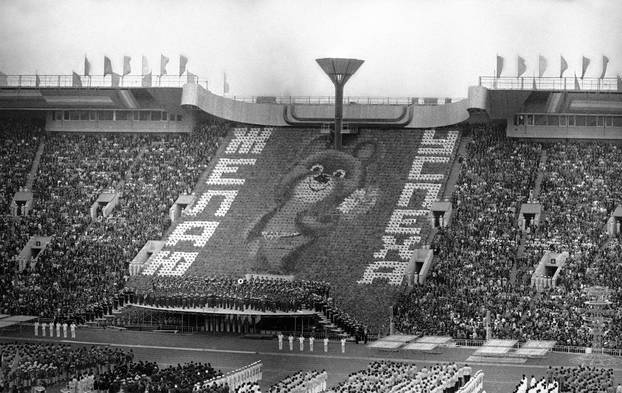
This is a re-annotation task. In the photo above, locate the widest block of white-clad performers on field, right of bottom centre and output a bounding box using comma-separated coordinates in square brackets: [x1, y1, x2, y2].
[327, 361, 471, 393]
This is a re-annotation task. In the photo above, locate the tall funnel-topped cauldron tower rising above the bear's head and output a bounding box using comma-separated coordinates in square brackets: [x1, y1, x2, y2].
[315, 58, 364, 150]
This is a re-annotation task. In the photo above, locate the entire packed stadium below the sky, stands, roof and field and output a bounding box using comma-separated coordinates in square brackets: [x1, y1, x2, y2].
[0, 2, 622, 393]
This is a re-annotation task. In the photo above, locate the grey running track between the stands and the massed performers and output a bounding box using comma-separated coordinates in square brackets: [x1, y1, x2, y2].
[0, 329, 622, 393]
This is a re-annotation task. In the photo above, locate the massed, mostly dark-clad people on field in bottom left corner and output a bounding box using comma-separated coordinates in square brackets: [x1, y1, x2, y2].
[0, 343, 259, 393]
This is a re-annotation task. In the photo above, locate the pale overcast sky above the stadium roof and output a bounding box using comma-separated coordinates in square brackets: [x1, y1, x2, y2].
[0, 0, 622, 97]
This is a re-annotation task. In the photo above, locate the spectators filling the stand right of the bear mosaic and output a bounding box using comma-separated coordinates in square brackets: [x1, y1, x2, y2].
[394, 125, 622, 348]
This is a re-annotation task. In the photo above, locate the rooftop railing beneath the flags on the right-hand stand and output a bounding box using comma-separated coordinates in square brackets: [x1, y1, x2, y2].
[479, 76, 622, 91]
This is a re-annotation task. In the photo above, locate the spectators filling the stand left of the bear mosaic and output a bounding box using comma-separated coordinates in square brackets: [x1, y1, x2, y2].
[0, 118, 227, 322]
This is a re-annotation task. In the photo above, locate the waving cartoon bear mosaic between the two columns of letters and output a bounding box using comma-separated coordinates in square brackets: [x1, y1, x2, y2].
[247, 139, 377, 274]
